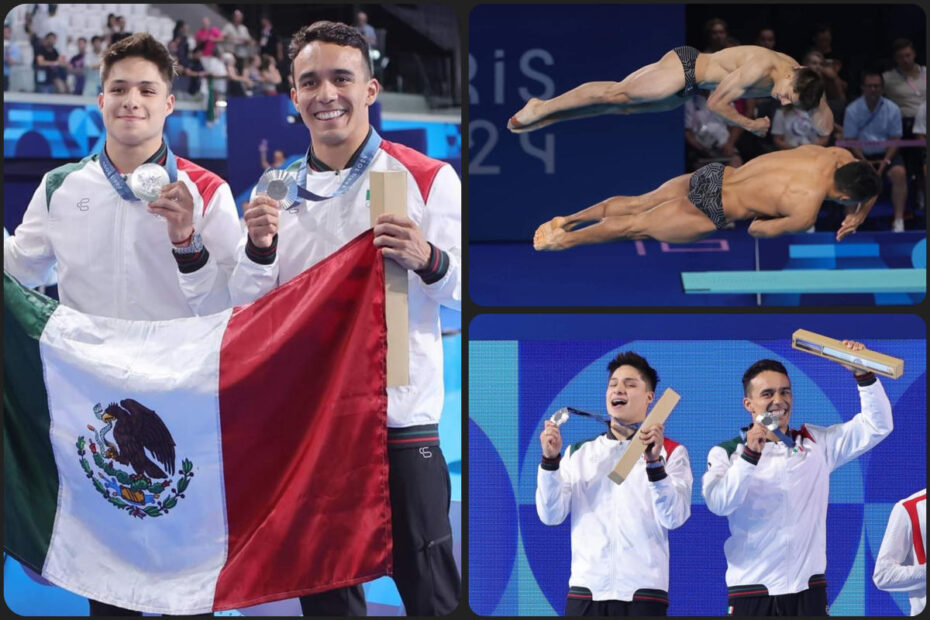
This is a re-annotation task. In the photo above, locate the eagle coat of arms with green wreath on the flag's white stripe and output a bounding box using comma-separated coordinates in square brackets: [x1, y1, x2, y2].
[75, 398, 194, 519]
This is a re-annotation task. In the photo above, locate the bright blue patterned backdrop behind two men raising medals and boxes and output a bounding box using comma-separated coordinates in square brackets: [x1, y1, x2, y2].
[468, 314, 927, 616]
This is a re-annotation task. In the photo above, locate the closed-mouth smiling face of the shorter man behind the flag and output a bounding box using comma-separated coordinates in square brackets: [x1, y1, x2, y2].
[97, 56, 174, 151]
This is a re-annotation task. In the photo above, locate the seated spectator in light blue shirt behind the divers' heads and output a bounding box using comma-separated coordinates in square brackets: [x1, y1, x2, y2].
[843, 69, 907, 232]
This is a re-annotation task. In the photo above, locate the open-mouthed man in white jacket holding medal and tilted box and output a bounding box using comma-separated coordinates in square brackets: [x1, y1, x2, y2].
[536, 352, 692, 616]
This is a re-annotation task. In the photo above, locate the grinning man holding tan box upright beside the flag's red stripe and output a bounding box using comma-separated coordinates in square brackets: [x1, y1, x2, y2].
[230, 22, 462, 616]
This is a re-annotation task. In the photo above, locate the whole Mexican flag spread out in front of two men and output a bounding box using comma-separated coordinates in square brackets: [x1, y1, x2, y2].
[3, 231, 391, 614]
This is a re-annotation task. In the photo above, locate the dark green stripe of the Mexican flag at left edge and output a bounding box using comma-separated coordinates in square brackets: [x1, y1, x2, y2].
[3, 273, 58, 572]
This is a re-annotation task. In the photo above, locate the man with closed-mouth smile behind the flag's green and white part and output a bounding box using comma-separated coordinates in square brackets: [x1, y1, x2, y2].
[3, 33, 241, 616]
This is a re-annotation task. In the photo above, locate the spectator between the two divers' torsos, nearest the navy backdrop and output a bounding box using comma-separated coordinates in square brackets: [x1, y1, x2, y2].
[685, 90, 743, 172]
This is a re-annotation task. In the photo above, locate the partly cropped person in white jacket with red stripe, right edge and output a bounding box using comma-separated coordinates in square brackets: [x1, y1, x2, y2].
[872, 489, 927, 616]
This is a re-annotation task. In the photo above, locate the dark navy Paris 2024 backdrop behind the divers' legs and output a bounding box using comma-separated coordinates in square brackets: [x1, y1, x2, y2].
[468, 5, 685, 242]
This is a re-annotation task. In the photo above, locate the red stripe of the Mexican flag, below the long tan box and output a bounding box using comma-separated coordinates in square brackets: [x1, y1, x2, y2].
[214, 231, 392, 610]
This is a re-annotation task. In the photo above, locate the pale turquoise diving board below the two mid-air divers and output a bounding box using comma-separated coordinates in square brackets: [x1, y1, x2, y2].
[681, 269, 927, 294]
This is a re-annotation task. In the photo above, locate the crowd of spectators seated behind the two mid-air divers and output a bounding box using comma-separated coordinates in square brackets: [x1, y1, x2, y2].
[685, 18, 927, 231]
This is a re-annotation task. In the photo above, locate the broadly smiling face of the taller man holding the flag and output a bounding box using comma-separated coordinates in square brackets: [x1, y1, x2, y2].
[291, 41, 380, 153]
